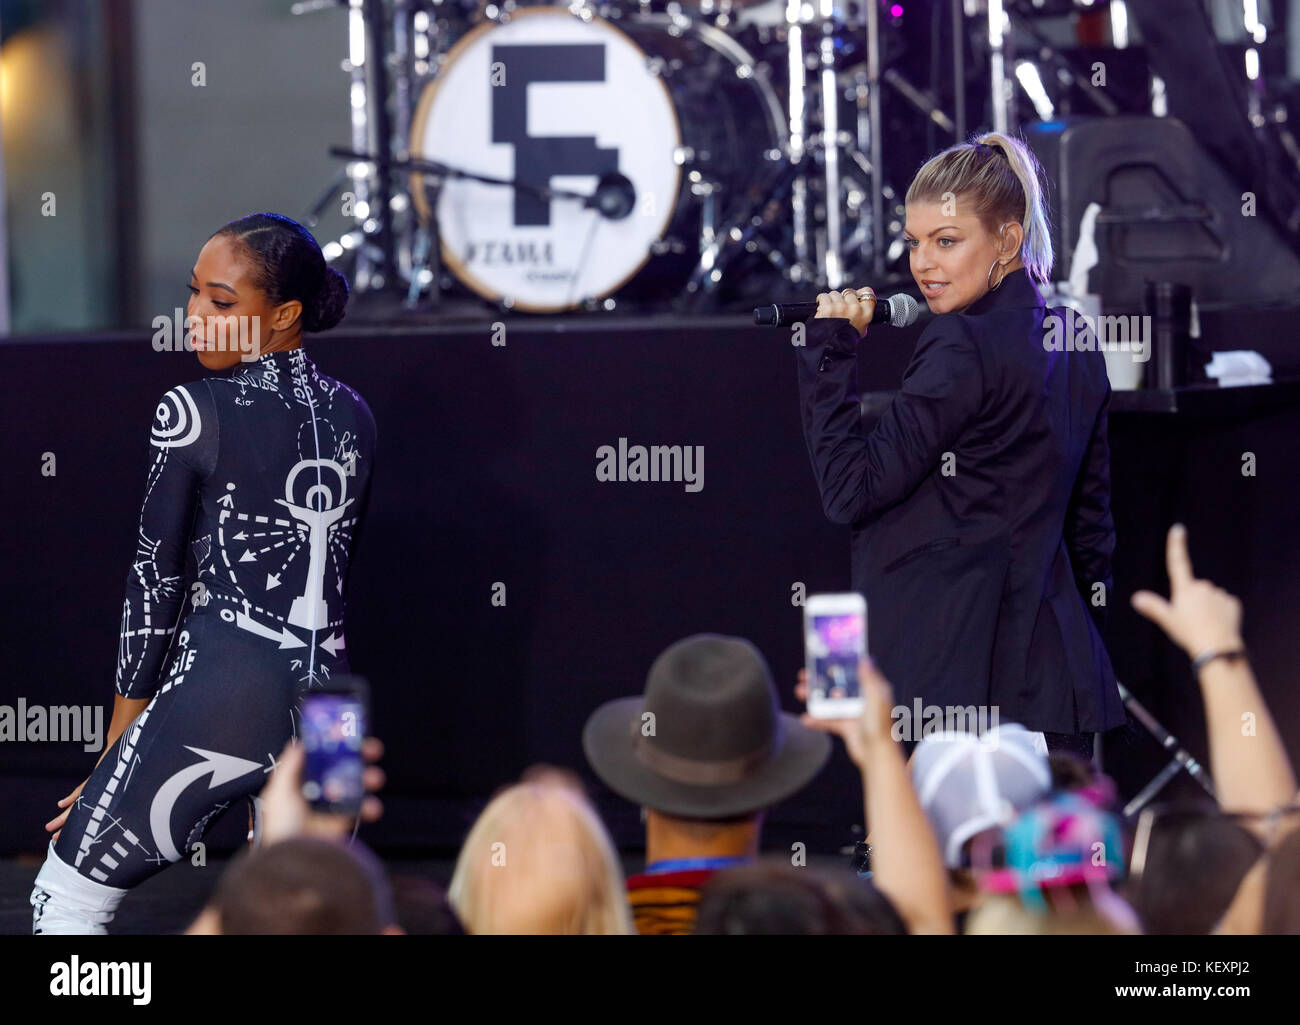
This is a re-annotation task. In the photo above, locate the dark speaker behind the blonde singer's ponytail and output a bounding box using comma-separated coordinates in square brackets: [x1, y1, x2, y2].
[1023, 117, 1300, 313]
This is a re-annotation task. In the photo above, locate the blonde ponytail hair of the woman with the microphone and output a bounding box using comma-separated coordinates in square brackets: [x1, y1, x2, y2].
[905, 131, 1052, 284]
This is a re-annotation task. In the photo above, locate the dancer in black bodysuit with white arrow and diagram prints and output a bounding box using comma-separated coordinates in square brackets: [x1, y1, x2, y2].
[31, 213, 374, 933]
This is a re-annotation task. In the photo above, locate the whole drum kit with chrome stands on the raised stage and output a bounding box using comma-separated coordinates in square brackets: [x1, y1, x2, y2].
[295, 0, 959, 313]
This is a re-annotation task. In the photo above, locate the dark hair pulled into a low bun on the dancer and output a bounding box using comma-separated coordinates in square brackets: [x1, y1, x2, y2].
[212, 213, 347, 332]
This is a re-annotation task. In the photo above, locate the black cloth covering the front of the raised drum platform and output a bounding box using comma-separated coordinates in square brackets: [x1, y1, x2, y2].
[0, 319, 1300, 853]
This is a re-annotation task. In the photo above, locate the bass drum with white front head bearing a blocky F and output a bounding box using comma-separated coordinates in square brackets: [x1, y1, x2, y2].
[411, 8, 787, 312]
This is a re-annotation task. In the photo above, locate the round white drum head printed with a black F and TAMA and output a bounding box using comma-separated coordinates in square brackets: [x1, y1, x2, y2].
[411, 8, 681, 312]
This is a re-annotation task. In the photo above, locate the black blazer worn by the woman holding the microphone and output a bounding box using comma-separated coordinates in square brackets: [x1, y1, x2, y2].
[796, 269, 1125, 734]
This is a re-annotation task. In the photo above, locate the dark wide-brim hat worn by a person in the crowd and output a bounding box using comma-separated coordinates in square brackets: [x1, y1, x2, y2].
[582, 633, 831, 819]
